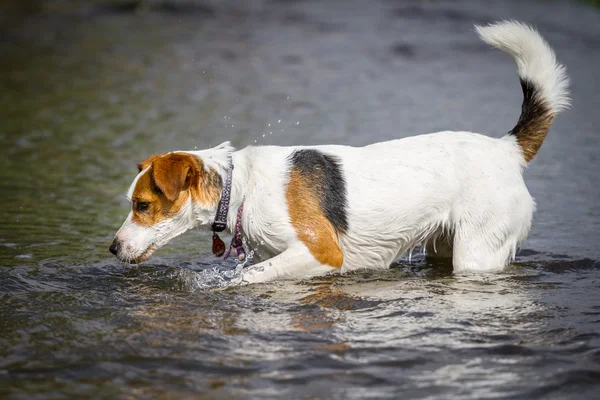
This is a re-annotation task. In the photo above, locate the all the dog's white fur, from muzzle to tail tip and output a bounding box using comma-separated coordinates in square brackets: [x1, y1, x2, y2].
[111, 22, 568, 283]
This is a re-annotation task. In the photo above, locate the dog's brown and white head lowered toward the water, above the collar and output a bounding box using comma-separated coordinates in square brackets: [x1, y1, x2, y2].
[110, 142, 233, 263]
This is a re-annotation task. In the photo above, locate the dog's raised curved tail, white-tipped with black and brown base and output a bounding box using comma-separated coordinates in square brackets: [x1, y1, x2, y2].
[475, 21, 570, 162]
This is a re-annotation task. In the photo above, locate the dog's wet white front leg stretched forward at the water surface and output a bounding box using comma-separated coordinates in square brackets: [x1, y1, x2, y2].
[240, 244, 340, 284]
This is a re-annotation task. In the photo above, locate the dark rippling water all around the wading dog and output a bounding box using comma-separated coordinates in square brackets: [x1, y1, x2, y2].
[0, 0, 600, 399]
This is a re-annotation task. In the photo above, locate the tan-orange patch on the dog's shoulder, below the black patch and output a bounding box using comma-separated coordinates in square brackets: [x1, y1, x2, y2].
[286, 167, 344, 268]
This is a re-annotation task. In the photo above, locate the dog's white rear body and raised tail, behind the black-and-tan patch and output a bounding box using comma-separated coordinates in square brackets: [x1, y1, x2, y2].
[288, 21, 569, 271]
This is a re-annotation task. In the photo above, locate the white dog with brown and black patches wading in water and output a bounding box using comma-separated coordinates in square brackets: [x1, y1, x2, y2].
[110, 21, 570, 283]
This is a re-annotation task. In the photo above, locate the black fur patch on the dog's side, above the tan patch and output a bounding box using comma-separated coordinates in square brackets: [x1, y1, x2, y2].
[290, 149, 348, 233]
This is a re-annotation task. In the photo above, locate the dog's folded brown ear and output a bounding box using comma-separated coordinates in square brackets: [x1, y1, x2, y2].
[152, 153, 200, 201]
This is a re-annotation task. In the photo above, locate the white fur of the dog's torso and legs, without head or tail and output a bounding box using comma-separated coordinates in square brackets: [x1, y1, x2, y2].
[229, 132, 535, 281]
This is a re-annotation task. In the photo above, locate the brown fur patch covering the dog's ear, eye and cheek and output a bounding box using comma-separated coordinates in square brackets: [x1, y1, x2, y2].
[131, 153, 222, 226]
